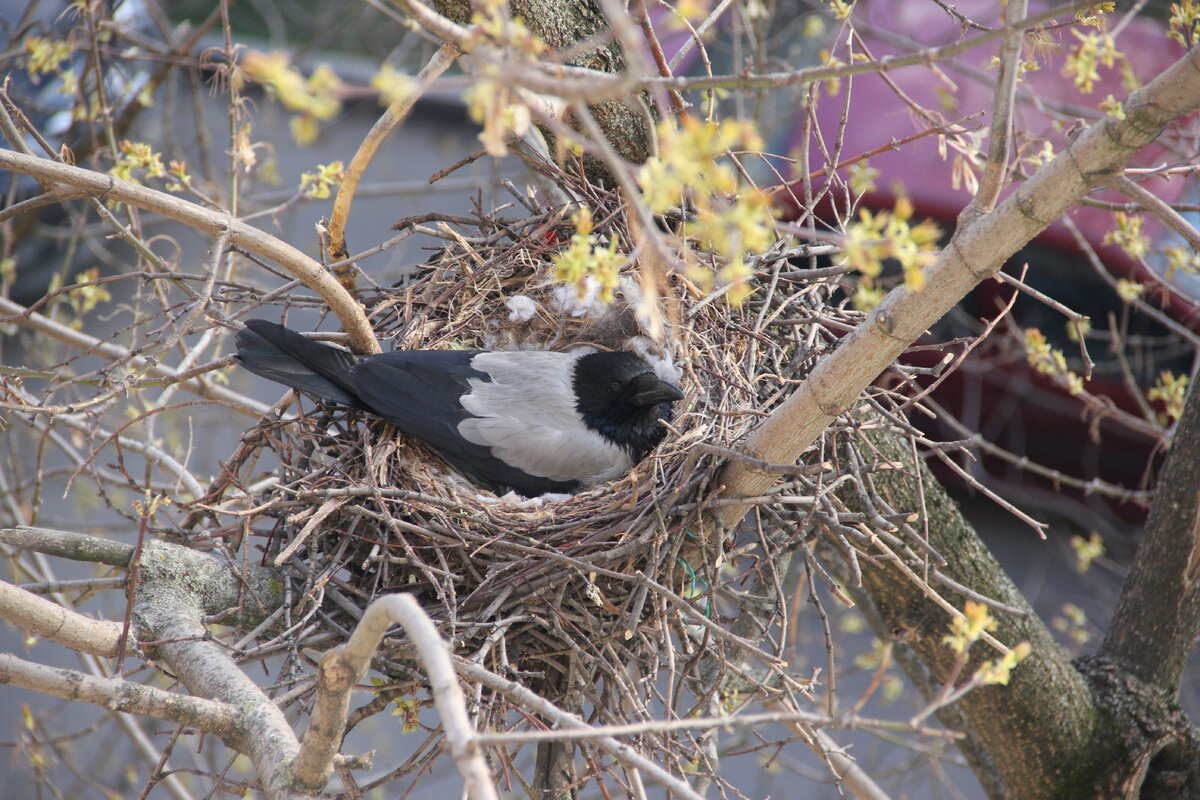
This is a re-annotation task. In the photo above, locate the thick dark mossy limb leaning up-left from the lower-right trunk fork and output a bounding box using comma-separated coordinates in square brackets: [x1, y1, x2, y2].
[863, 432, 1111, 800]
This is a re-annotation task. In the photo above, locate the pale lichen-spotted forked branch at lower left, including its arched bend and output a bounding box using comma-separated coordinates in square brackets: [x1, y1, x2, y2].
[0, 528, 498, 800]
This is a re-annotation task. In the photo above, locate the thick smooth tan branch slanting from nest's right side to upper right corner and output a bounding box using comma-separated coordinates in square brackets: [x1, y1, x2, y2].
[719, 42, 1200, 529]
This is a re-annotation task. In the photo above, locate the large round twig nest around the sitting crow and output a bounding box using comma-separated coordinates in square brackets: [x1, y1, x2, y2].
[196, 181, 848, 700]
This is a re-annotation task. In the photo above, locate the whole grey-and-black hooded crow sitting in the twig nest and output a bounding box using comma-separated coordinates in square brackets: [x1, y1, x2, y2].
[236, 319, 683, 497]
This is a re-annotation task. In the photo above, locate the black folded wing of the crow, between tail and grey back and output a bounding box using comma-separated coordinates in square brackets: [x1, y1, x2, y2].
[350, 350, 580, 495]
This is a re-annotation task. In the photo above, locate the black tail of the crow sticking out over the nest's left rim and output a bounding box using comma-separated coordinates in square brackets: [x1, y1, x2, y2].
[235, 319, 362, 408]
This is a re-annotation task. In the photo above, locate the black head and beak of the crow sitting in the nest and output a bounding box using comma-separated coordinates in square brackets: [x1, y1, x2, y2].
[574, 353, 683, 461]
